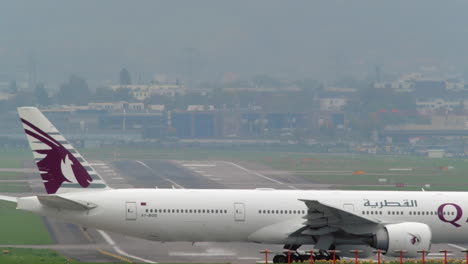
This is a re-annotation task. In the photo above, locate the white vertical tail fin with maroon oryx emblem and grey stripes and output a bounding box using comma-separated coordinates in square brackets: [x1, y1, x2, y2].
[18, 107, 108, 194]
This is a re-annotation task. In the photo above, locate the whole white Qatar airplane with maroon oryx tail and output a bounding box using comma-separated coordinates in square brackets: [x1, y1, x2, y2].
[0, 107, 468, 263]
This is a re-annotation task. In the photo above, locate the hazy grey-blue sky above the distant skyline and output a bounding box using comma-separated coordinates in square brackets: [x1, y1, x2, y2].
[0, 0, 468, 86]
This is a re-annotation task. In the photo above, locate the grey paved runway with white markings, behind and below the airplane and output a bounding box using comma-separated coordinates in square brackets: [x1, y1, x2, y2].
[5, 160, 468, 263]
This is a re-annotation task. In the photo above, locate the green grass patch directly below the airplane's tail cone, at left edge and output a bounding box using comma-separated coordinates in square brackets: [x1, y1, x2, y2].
[0, 202, 52, 244]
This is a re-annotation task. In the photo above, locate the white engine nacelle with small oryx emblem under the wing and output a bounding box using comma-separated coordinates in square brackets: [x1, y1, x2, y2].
[371, 222, 432, 258]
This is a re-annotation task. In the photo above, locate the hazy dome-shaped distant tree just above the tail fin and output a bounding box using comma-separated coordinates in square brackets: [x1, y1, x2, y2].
[57, 75, 91, 105]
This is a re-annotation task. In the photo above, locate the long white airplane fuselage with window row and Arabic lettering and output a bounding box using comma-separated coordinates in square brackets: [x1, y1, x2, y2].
[18, 189, 468, 244]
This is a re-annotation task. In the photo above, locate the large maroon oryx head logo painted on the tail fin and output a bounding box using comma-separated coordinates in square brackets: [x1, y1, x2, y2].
[21, 118, 93, 194]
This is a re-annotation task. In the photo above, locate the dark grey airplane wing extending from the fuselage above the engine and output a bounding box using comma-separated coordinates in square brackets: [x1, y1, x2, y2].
[298, 199, 380, 236]
